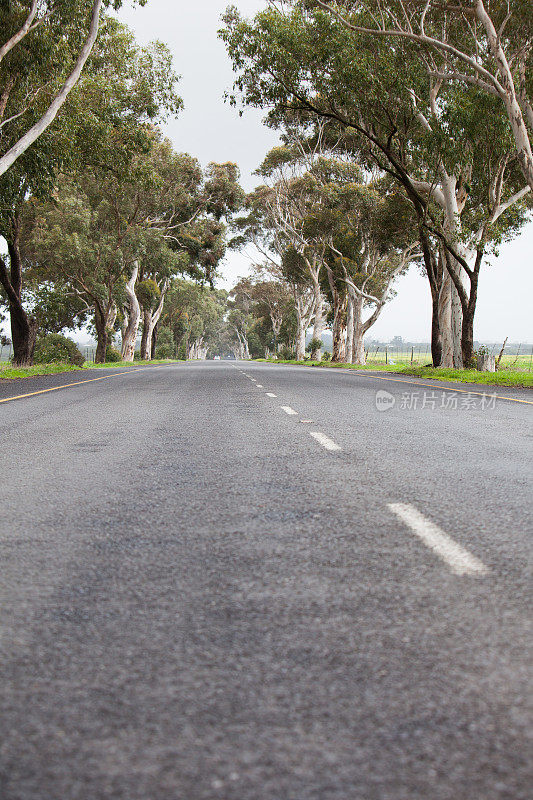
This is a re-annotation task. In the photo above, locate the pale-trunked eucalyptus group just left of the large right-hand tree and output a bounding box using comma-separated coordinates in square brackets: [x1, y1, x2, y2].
[249, 131, 416, 362]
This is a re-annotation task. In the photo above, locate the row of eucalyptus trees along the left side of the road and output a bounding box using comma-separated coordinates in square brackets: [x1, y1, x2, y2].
[0, 0, 243, 365]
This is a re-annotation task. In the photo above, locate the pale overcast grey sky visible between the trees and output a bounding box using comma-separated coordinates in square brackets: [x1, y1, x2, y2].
[120, 0, 533, 342]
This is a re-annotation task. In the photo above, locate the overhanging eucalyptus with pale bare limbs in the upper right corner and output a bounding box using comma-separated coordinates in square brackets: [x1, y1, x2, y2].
[316, 0, 533, 191]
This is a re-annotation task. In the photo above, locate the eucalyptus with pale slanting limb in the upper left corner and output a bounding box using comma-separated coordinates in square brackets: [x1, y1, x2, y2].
[0, 0, 146, 176]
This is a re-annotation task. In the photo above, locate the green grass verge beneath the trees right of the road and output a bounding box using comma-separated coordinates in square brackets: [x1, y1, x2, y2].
[256, 358, 533, 388]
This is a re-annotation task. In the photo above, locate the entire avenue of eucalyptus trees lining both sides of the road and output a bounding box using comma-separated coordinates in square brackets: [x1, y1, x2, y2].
[0, 0, 533, 368]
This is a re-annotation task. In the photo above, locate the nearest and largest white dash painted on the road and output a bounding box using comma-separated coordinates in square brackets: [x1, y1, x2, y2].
[387, 503, 490, 575]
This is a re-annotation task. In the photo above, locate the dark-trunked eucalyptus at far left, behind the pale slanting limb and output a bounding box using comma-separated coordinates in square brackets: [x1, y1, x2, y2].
[0, 18, 181, 363]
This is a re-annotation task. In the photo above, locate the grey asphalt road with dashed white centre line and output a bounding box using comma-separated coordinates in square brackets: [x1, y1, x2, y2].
[0, 362, 533, 800]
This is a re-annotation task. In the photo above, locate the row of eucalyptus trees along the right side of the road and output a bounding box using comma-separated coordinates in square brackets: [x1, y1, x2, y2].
[220, 0, 533, 368]
